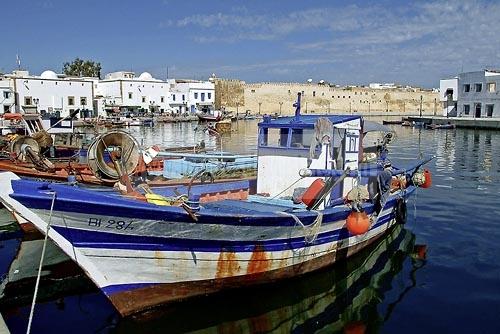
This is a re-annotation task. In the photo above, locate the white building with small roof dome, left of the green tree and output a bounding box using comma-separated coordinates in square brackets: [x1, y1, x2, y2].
[5, 71, 94, 117]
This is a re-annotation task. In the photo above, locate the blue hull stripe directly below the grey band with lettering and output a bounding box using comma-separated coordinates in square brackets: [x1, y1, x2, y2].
[52, 213, 394, 253]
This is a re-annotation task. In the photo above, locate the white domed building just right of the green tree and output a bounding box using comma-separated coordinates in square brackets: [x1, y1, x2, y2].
[94, 71, 169, 116]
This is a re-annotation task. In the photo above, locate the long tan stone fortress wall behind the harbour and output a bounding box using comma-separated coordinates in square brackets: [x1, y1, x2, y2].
[215, 79, 440, 115]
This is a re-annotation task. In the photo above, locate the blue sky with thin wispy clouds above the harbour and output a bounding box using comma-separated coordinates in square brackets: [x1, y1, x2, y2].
[0, 0, 500, 87]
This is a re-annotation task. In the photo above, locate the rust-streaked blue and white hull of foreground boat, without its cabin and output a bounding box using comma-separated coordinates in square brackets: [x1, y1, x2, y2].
[0, 173, 411, 316]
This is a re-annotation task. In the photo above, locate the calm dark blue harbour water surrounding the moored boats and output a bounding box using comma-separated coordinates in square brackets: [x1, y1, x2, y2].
[0, 121, 500, 333]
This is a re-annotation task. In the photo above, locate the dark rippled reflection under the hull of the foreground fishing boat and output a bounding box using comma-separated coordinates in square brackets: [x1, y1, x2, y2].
[115, 225, 425, 333]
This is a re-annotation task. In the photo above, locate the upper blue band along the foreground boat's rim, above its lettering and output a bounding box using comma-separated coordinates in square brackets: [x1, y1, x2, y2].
[11, 177, 414, 226]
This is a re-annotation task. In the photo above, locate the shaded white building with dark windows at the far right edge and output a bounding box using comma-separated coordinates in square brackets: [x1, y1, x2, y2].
[457, 70, 500, 118]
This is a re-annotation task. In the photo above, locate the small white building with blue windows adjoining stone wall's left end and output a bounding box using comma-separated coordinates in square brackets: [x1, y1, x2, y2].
[168, 79, 215, 114]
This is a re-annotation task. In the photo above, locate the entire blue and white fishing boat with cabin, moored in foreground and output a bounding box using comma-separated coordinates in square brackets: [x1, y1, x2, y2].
[0, 94, 430, 316]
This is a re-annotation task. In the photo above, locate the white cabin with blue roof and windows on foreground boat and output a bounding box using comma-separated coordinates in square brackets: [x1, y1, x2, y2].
[257, 112, 362, 198]
